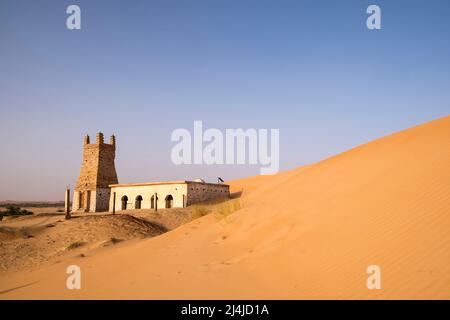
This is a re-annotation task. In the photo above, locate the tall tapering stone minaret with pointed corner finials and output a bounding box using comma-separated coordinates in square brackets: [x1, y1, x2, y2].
[72, 132, 118, 212]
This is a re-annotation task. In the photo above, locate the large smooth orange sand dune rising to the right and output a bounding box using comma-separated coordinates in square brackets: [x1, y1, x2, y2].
[0, 117, 450, 299]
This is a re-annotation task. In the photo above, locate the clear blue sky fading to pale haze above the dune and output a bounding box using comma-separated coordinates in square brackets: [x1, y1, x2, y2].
[0, 0, 450, 200]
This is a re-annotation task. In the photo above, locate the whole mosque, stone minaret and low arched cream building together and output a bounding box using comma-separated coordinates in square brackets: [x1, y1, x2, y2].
[72, 132, 230, 212]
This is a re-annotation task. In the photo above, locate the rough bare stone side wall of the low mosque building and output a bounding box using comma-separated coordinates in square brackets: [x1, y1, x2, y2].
[187, 182, 230, 206]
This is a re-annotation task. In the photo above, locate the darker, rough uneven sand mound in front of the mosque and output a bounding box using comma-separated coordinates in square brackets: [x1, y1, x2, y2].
[0, 209, 197, 274]
